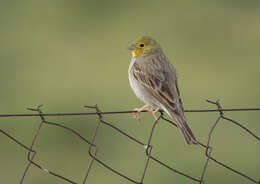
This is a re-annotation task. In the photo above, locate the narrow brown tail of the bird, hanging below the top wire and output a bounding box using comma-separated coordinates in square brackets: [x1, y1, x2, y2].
[169, 111, 198, 144]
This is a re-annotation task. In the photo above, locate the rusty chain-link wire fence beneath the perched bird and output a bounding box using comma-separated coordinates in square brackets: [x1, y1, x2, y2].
[0, 100, 260, 184]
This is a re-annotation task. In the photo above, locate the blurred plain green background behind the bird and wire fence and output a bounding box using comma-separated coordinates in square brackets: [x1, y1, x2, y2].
[0, 0, 260, 184]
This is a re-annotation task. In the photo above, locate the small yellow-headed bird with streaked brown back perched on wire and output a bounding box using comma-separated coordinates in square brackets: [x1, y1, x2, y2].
[128, 36, 198, 144]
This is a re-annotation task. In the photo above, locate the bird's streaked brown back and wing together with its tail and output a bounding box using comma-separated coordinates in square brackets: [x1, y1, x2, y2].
[132, 55, 198, 144]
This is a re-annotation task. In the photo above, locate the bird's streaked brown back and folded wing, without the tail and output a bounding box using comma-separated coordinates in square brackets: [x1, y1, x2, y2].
[133, 54, 183, 110]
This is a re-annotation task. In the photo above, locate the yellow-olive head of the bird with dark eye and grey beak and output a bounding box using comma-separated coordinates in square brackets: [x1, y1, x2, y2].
[128, 36, 161, 57]
